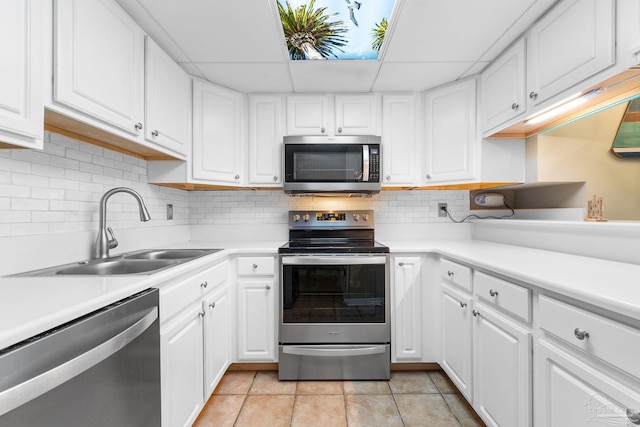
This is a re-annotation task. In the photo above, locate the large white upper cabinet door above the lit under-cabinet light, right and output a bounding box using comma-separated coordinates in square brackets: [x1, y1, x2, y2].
[527, 0, 615, 106]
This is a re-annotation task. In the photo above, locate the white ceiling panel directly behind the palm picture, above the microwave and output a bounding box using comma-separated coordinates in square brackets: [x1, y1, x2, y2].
[289, 61, 380, 92]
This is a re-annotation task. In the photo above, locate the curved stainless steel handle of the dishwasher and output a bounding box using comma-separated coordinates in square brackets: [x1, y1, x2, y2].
[0, 307, 158, 415]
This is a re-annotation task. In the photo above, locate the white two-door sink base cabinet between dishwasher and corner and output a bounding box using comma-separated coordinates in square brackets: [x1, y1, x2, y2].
[160, 260, 231, 427]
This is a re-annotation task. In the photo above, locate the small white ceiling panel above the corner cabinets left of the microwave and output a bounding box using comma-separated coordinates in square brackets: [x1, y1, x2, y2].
[194, 62, 293, 93]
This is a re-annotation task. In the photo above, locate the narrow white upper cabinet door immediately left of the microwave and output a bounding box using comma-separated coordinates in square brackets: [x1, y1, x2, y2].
[249, 95, 283, 185]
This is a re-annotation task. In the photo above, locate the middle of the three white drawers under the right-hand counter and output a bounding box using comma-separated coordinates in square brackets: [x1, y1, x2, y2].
[473, 272, 531, 323]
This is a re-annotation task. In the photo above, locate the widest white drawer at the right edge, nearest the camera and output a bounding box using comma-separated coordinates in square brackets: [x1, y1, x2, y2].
[539, 295, 640, 378]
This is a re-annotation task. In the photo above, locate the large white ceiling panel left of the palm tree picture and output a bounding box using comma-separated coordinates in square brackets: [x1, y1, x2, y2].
[138, 0, 285, 62]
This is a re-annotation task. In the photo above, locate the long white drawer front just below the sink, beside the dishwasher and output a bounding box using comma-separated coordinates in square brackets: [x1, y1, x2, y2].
[160, 261, 229, 323]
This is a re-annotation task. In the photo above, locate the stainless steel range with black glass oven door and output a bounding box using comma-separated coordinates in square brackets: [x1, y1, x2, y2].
[279, 210, 391, 380]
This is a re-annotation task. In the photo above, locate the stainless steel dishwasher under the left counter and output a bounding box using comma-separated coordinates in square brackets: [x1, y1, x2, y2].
[0, 289, 160, 427]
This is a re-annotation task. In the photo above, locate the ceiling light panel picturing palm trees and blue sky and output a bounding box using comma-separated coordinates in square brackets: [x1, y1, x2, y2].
[278, 0, 395, 60]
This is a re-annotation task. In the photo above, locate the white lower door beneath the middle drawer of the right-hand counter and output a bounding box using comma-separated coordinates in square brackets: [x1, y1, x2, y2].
[473, 303, 532, 427]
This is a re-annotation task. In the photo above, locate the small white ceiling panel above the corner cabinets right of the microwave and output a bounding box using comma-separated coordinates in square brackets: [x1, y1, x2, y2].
[373, 62, 473, 92]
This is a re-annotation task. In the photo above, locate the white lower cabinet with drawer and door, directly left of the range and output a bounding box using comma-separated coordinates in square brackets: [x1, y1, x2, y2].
[236, 256, 277, 362]
